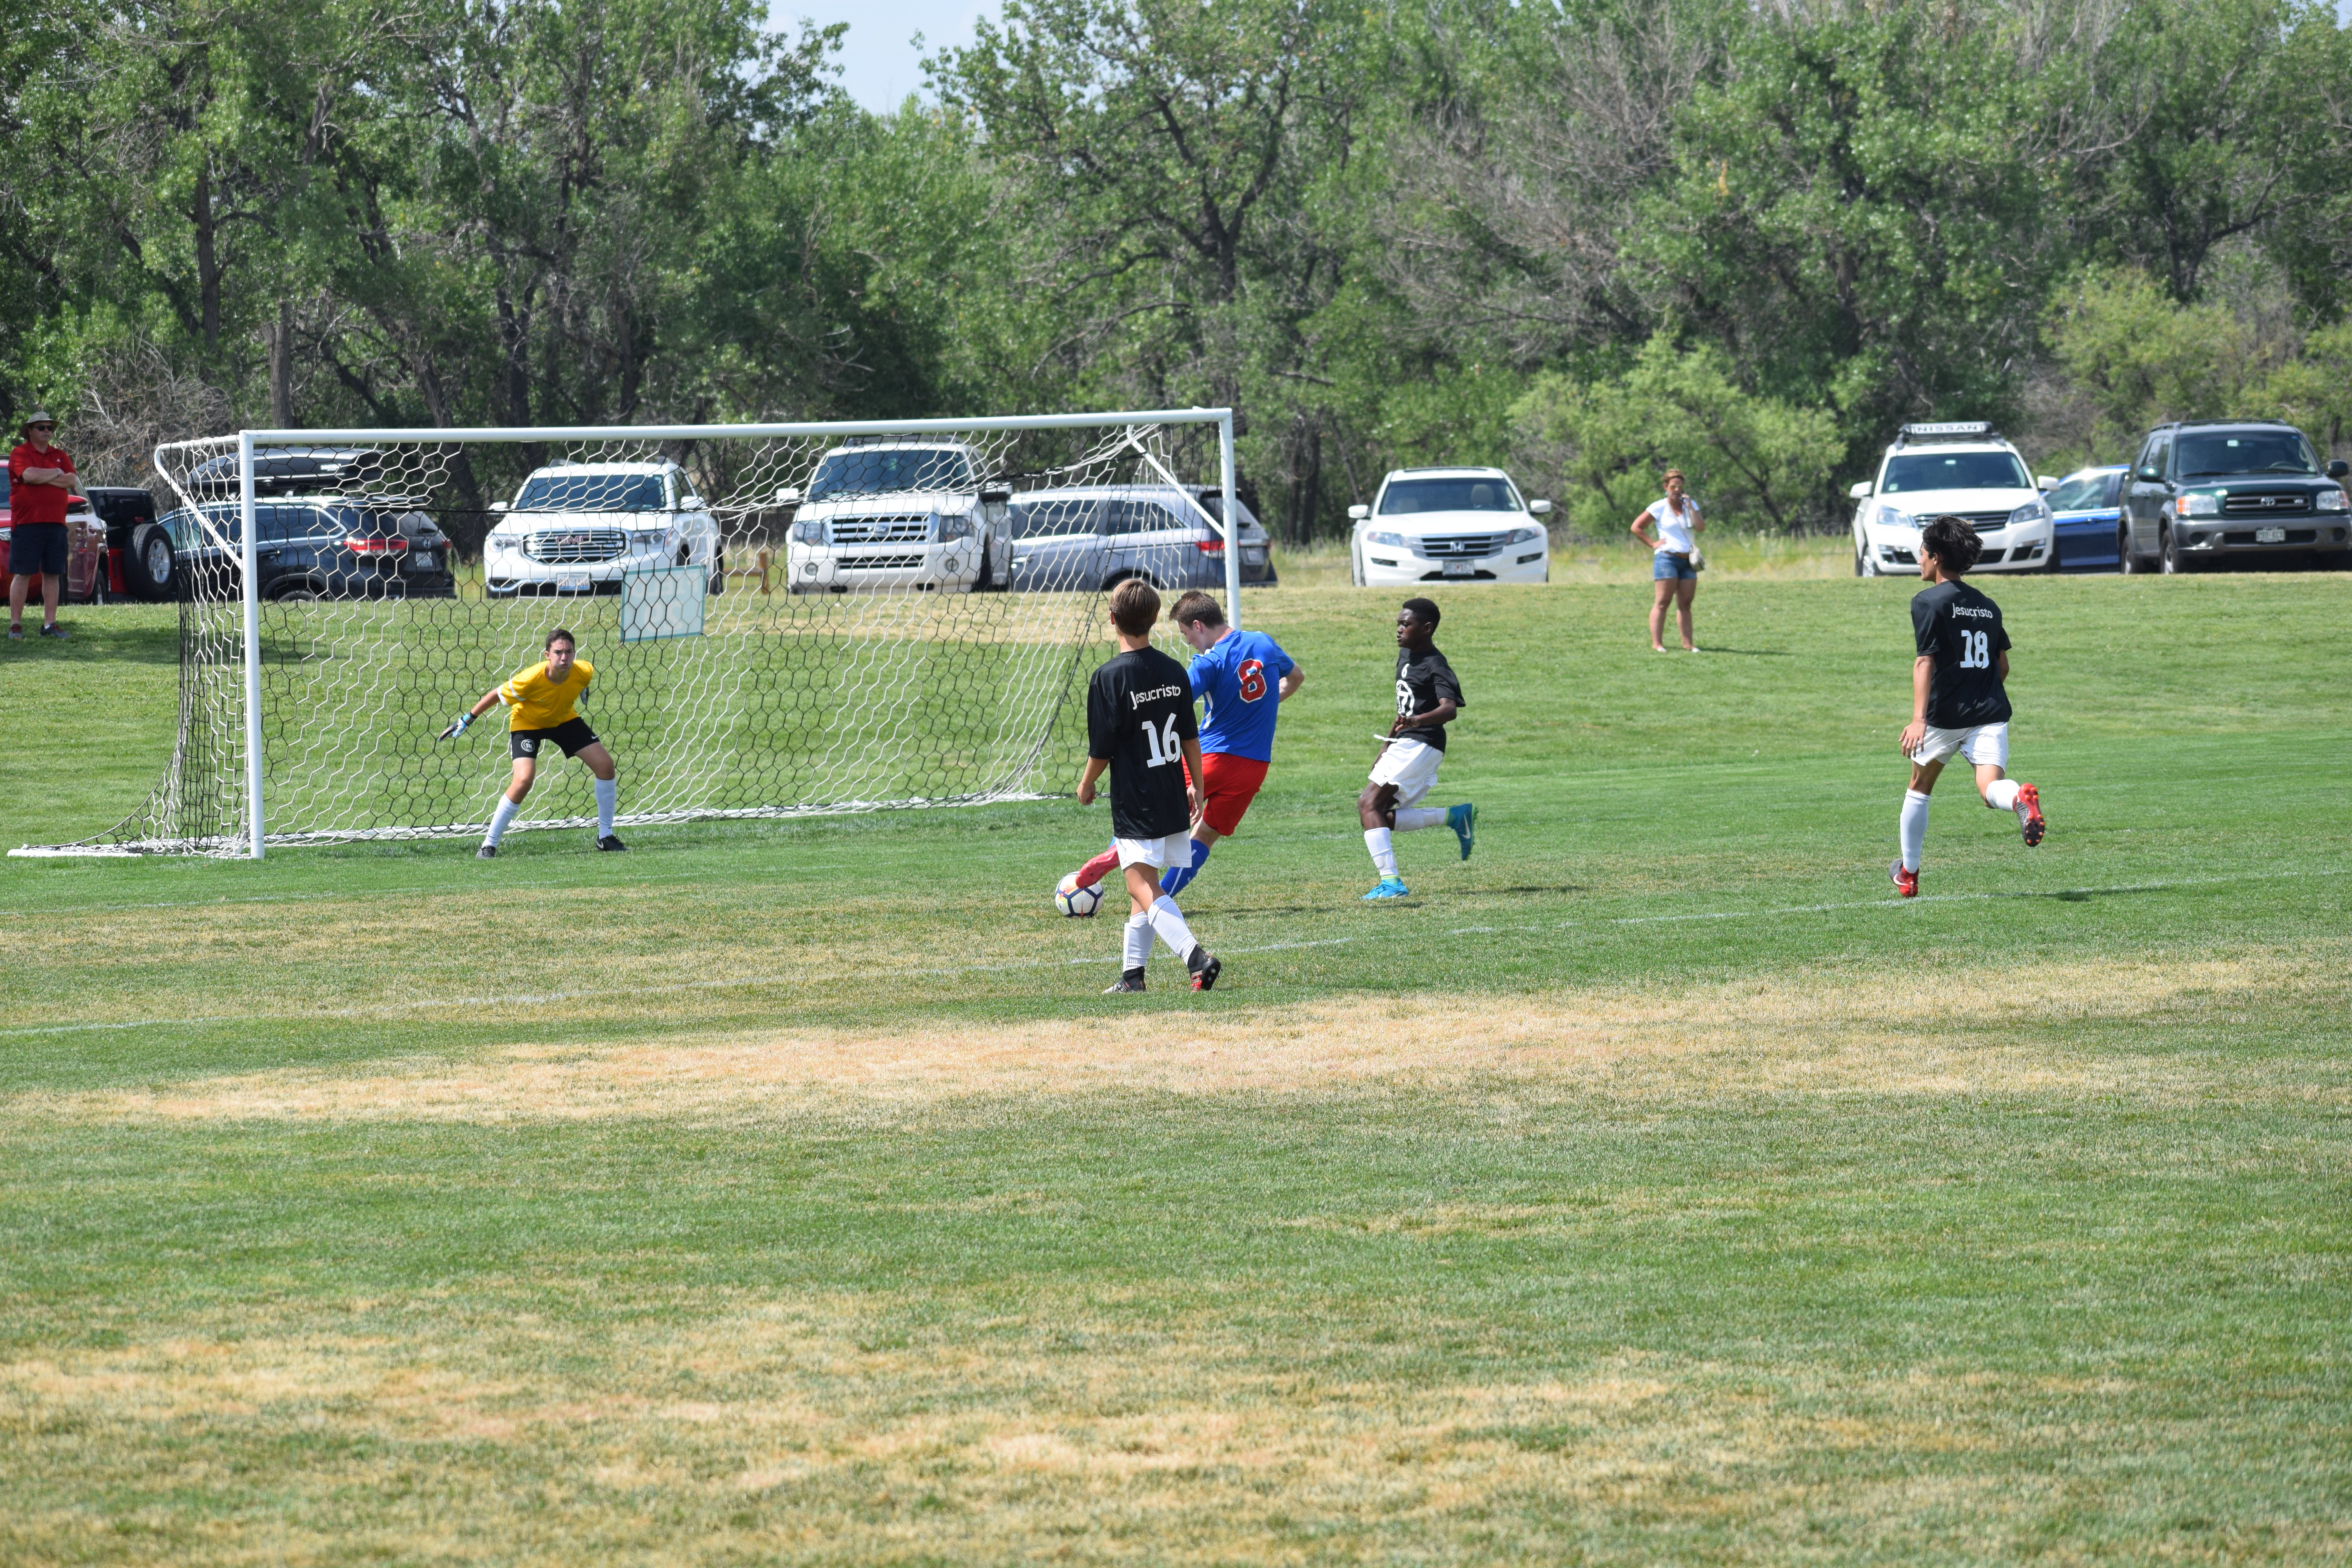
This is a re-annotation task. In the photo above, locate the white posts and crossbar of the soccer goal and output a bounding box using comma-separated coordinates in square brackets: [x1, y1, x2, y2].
[9, 407, 1242, 860]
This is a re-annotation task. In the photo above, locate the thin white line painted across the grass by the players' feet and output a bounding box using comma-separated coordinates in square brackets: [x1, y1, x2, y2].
[0, 867, 2340, 1039]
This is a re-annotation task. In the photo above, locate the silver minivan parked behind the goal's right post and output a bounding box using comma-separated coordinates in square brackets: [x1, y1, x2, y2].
[1011, 484, 1279, 592]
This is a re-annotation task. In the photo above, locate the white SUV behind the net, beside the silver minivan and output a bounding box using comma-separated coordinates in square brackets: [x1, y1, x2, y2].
[776, 435, 1011, 592]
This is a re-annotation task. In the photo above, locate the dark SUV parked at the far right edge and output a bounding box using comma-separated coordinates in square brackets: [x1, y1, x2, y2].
[2117, 418, 2352, 571]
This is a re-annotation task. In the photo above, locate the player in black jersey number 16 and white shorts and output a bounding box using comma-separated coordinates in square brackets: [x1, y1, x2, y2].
[1077, 578, 1223, 992]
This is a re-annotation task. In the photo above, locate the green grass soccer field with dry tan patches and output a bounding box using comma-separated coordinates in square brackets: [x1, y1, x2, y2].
[0, 562, 2352, 1563]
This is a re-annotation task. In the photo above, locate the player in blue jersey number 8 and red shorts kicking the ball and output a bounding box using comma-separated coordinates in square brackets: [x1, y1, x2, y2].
[1063, 588, 1305, 893]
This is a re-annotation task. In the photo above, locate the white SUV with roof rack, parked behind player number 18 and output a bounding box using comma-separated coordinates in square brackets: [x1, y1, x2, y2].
[1846, 421, 2058, 576]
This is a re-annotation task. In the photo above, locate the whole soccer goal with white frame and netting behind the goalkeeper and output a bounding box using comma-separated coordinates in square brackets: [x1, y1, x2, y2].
[12, 409, 1270, 858]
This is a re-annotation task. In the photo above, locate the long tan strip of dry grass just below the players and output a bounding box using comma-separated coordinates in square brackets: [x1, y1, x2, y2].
[14, 947, 2352, 1122]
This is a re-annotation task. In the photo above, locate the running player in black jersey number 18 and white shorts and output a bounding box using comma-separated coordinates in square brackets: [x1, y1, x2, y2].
[1886, 517, 2046, 898]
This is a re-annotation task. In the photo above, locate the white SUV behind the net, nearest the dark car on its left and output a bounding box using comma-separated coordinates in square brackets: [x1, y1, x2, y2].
[482, 463, 727, 599]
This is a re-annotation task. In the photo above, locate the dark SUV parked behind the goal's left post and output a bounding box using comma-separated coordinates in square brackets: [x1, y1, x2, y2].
[162, 496, 456, 602]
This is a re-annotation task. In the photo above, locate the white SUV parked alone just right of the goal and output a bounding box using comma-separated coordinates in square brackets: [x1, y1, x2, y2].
[1348, 468, 1552, 588]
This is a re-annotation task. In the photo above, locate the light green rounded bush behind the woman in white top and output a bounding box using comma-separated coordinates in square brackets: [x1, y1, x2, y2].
[1512, 334, 1844, 538]
